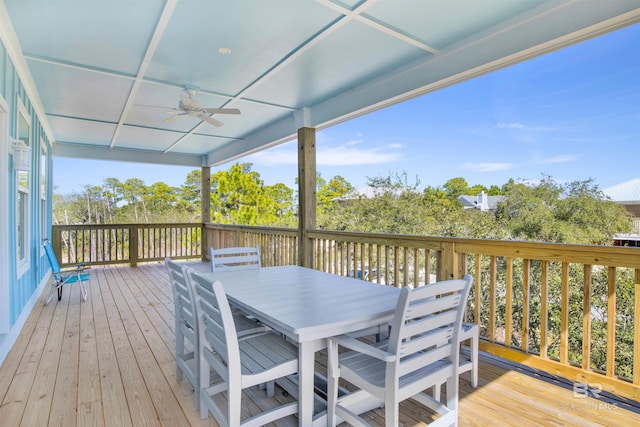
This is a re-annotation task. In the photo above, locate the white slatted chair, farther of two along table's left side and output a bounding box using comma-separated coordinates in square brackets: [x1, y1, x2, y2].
[164, 258, 267, 409]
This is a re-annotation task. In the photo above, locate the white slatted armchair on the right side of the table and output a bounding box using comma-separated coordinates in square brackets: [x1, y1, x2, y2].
[327, 275, 472, 427]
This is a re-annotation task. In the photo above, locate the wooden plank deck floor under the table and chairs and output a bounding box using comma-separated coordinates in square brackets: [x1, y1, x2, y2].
[0, 264, 640, 427]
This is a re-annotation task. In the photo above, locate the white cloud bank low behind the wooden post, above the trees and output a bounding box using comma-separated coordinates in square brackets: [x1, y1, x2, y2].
[246, 139, 402, 166]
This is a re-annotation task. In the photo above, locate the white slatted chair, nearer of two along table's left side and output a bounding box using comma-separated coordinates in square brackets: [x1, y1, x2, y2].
[188, 270, 298, 426]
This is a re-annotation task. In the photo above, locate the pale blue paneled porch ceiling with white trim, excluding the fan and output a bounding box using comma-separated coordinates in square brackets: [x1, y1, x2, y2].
[0, 0, 640, 166]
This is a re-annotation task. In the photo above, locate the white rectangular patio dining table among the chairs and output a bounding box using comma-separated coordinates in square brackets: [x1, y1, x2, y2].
[201, 266, 400, 427]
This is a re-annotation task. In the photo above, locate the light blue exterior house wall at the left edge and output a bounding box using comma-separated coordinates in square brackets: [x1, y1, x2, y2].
[0, 26, 53, 363]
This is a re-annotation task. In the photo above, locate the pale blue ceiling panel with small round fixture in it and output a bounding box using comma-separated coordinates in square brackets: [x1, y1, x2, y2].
[148, 0, 339, 95]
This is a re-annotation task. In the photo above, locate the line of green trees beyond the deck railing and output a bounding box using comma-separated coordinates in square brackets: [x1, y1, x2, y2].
[53, 163, 632, 244]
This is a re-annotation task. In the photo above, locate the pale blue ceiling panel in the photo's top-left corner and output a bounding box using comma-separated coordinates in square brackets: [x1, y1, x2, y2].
[6, 0, 164, 74]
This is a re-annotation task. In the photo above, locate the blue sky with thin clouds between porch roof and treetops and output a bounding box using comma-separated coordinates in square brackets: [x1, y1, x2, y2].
[53, 24, 640, 194]
